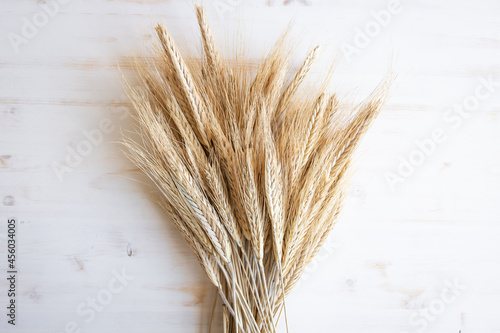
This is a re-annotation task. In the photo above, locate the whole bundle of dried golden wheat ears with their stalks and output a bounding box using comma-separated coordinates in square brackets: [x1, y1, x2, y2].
[124, 7, 389, 333]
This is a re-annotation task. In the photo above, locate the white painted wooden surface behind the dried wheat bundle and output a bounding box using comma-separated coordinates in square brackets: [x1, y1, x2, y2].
[0, 0, 500, 333]
